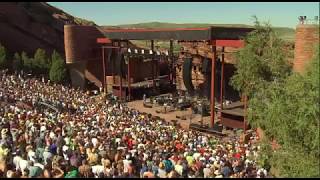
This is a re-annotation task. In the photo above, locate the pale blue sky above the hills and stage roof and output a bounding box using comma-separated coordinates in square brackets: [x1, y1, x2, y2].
[49, 2, 319, 28]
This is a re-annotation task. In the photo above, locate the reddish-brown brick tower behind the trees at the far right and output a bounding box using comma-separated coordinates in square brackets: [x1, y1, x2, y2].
[293, 24, 319, 72]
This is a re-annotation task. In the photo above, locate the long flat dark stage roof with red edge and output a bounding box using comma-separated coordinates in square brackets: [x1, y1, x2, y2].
[100, 26, 254, 41]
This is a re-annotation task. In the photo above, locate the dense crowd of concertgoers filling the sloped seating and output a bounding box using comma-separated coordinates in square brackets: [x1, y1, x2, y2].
[0, 71, 268, 178]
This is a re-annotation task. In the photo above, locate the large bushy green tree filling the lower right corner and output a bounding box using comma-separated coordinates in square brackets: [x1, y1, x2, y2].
[248, 44, 320, 177]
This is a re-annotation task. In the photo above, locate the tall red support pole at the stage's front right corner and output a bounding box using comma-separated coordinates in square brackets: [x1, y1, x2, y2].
[211, 40, 217, 128]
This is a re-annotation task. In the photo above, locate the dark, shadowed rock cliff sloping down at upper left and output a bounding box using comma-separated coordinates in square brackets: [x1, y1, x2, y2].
[0, 2, 95, 56]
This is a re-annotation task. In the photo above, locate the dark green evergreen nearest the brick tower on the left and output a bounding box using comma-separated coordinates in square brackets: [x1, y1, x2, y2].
[49, 51, 67, 83]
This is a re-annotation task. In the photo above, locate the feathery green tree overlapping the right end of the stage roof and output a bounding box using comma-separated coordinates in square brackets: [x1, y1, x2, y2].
[231, 17, 291, 98]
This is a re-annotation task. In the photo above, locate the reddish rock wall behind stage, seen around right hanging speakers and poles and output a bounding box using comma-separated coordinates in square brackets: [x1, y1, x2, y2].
[176, 42, 240, 101]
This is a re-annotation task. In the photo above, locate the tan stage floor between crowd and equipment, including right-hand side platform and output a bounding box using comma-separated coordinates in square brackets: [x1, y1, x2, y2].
[127, 100, 247, 136]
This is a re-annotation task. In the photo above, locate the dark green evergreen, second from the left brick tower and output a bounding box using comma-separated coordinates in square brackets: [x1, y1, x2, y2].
[32, 48, 50, 74]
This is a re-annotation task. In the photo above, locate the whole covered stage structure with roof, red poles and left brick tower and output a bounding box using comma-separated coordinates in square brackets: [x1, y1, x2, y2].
[65, 25, 253, 130]
